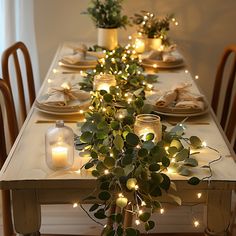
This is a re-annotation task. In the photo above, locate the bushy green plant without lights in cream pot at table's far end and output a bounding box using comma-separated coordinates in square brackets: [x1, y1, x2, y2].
[84, 0, 129, 50]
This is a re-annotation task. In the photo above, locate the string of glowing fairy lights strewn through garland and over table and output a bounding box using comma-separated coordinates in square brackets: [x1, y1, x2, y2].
[48, 14, 222, 232]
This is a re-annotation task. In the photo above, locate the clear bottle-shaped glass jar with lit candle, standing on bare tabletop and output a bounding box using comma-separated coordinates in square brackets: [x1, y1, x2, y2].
[45, 120, 74, 170]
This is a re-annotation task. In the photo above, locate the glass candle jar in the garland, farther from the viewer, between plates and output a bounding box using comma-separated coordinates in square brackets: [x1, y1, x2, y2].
[93, 74, 116, 92]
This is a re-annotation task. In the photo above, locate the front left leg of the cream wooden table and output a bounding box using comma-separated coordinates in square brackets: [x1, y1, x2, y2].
[12, 190, 41, 236]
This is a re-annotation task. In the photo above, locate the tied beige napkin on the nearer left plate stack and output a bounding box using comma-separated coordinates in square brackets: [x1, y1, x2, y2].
[41, 82, 90, 106]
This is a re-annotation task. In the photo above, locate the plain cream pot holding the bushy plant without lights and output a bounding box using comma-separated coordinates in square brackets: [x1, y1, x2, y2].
[98, 28, 118, 50]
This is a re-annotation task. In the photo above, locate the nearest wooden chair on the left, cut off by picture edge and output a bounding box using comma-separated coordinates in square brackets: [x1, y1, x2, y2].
[0, 79, 19, 236]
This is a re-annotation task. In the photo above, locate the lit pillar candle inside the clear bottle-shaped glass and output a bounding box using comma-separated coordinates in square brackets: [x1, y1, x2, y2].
[52, 144, 68, 168]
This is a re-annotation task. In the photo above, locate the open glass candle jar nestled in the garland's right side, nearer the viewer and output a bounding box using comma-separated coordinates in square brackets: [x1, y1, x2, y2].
[134, 114, 162, 143]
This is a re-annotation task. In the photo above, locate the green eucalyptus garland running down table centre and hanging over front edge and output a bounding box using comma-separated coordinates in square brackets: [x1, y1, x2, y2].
[75, 46, 202, 235]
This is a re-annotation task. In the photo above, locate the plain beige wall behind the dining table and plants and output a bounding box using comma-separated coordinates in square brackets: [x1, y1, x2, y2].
[34, 0, 236, 101]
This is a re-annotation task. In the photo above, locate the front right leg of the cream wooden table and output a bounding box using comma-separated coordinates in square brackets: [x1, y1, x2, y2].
[205, 190, 231, 236]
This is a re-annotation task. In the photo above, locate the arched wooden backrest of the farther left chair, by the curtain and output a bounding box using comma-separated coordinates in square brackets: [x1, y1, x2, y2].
[2, 42, 35, 123]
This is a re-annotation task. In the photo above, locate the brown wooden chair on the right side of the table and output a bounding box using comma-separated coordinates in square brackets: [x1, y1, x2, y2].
[211, 45, 236, 150]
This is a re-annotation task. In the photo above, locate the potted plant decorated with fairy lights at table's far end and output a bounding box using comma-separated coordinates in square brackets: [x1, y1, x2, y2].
[133, 11, 174, 50]
